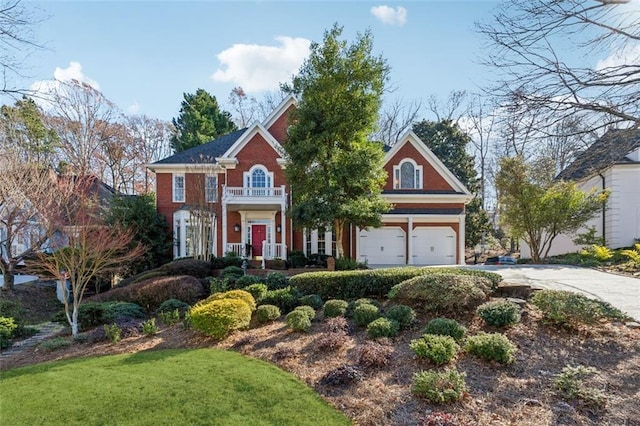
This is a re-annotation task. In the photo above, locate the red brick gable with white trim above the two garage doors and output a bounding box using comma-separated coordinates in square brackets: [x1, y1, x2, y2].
[384, 131, 470, 195]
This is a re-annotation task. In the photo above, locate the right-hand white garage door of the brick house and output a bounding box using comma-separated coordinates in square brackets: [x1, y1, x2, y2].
[412, 226, 456, 265]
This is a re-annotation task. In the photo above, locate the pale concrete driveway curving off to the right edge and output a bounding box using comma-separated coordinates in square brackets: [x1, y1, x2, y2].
[469, 265, 640, 321]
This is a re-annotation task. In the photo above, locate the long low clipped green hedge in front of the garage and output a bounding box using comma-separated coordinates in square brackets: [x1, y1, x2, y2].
[289, 267, 502, 300]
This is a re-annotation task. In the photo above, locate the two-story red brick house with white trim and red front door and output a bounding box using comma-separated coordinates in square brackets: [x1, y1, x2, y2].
[148, 97, 472, 265]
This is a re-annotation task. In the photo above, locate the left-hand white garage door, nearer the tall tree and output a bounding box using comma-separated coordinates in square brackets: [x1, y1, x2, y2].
[359, 227, 406, 265]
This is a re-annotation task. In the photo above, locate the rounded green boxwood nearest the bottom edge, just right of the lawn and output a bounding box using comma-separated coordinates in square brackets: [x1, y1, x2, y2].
[411, 368, 467, 404]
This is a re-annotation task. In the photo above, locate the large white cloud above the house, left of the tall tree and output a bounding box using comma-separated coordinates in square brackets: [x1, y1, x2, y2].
[211, 36, 311, 92]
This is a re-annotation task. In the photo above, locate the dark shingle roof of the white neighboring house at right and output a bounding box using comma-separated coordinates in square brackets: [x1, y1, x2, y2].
[556, 129, 640, 180]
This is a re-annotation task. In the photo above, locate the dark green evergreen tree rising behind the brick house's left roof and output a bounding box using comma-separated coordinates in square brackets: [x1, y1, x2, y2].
[171, 89, 237, 152]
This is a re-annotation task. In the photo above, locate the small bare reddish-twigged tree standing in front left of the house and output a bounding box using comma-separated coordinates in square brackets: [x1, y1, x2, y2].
[27, 178, 144, 336]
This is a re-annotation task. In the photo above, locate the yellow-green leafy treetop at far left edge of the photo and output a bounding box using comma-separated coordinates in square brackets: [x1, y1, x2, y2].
[0, 97, 59, 165]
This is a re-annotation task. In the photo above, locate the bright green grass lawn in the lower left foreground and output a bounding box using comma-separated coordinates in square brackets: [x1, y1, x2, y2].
[0, 349, 350, 425]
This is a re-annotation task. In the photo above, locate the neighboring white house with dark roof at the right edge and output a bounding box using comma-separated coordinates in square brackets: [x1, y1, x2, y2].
[520, 130, 640, 258]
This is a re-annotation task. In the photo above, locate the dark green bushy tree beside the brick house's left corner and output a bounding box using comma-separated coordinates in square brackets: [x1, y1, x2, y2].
[107, 194, 171, 274]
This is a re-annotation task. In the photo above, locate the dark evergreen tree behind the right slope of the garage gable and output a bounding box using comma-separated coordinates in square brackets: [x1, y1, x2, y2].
[413, 119, 491, 247]
